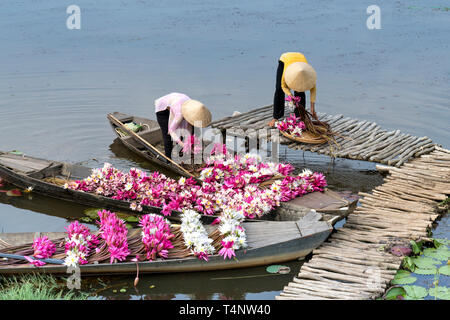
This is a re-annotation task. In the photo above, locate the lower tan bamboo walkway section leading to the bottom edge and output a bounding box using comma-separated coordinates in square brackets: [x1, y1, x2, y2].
[276, 146, 450, 300]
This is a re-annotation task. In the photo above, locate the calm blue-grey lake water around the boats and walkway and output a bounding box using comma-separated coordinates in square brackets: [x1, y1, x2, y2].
[0, 0, 450, 299]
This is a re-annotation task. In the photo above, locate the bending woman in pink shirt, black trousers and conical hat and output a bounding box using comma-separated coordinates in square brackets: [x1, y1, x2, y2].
[155, 92, 211, 158]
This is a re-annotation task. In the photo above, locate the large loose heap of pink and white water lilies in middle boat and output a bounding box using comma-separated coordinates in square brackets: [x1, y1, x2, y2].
[65, 147, 327, 219]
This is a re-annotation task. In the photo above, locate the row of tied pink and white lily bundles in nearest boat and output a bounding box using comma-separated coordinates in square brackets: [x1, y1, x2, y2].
[17, 210, 246, 267]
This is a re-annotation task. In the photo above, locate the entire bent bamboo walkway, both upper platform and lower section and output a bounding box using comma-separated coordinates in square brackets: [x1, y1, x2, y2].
[212, 106, 450, 300]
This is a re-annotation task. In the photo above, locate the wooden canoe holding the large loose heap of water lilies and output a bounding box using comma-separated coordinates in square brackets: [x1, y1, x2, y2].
[0, 152, 357, 222]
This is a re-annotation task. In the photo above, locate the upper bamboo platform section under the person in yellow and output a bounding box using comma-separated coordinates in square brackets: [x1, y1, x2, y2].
[211, 105, 435, 167]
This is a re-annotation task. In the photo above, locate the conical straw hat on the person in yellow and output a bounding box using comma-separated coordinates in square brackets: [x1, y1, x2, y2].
[284, 62, 317, 92]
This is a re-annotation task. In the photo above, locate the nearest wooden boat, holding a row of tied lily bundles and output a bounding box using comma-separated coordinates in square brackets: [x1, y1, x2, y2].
[0, 211, 333, 276]
